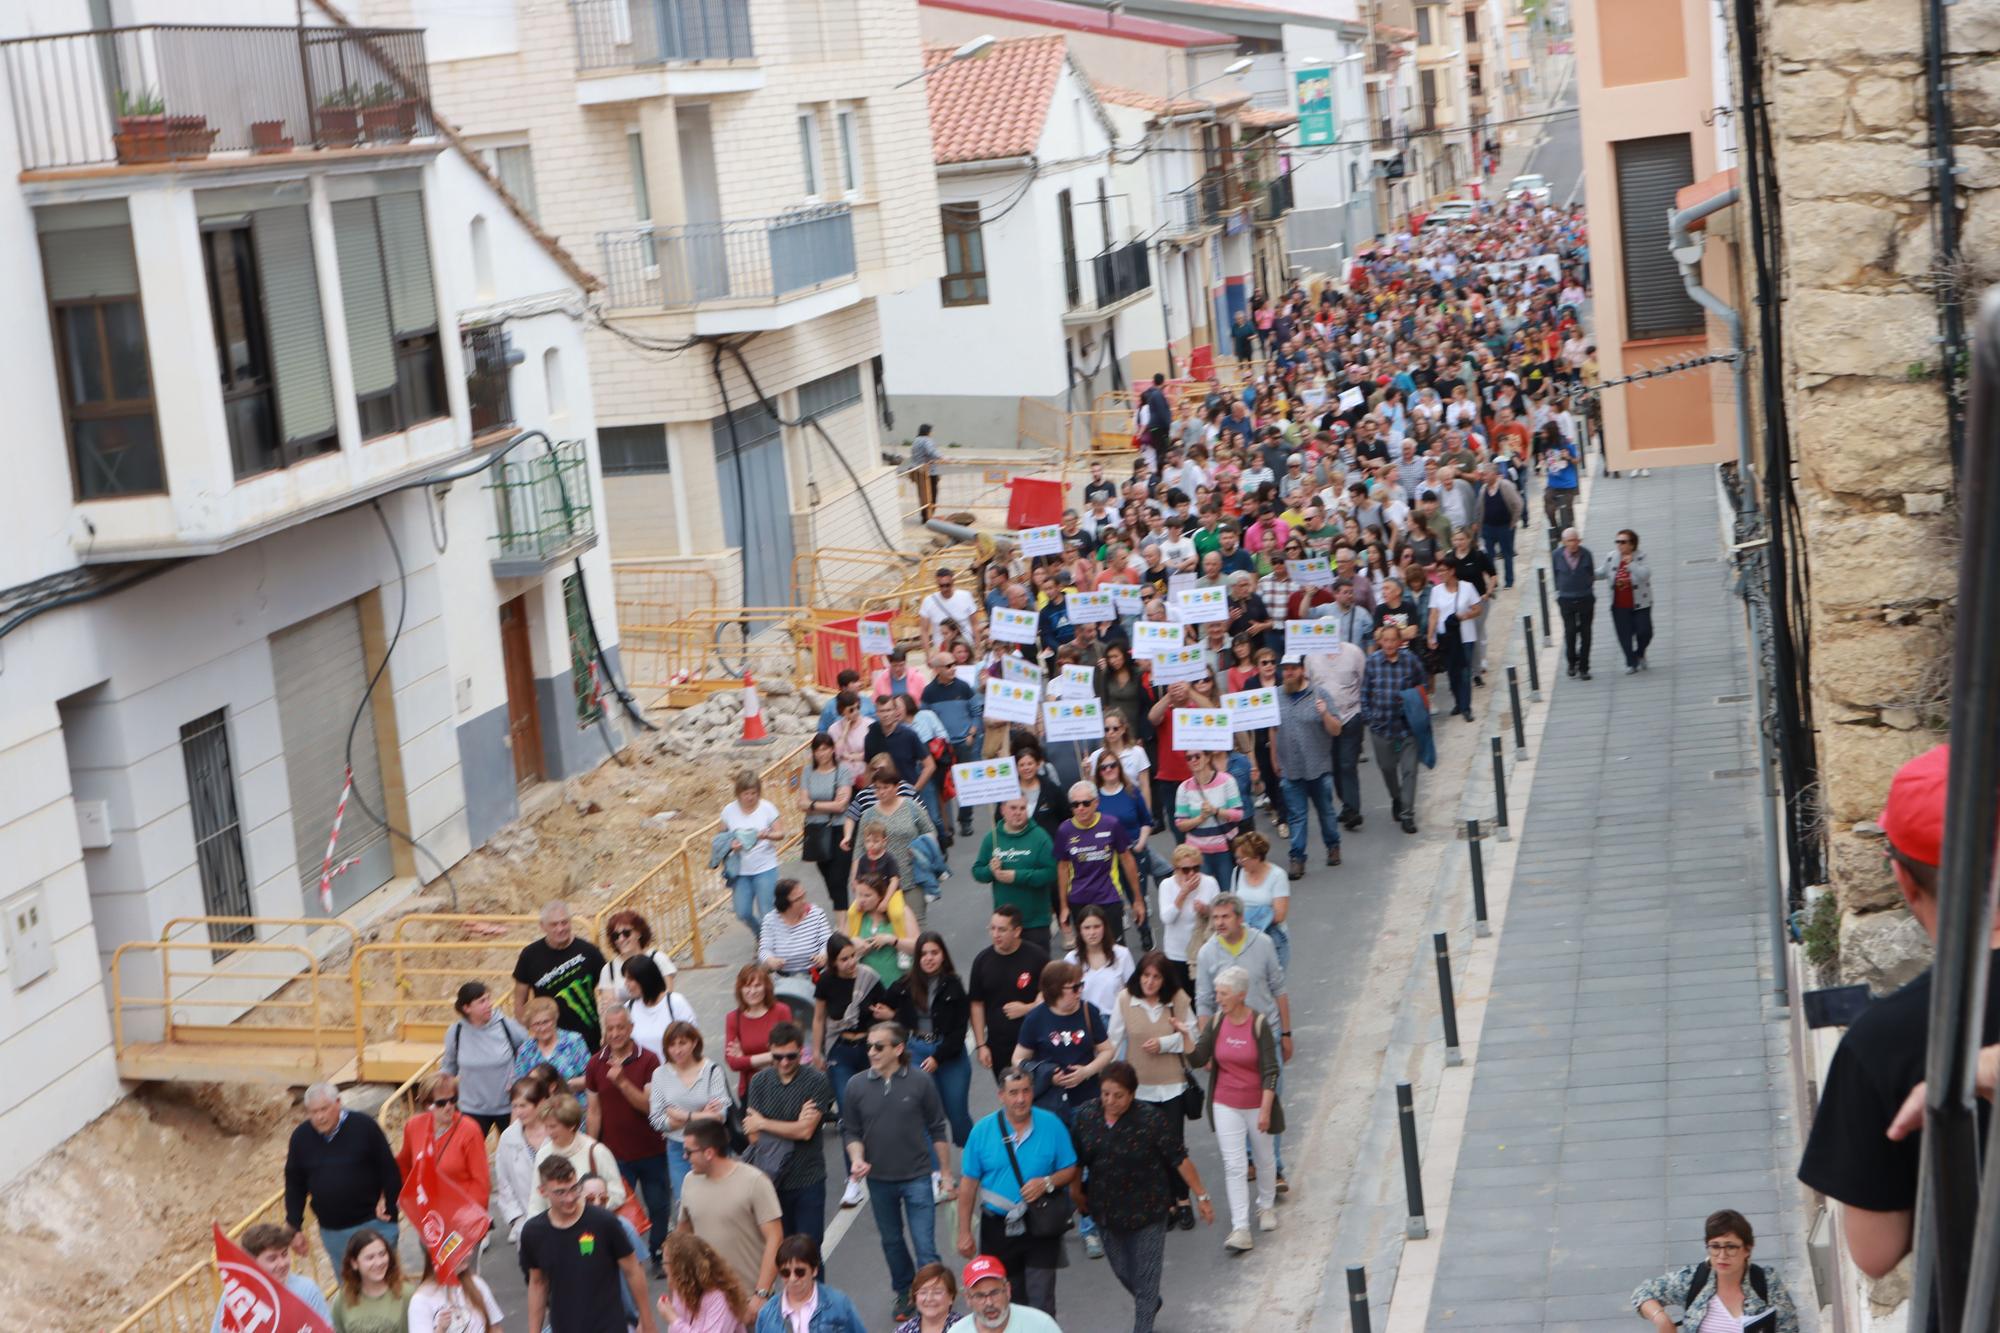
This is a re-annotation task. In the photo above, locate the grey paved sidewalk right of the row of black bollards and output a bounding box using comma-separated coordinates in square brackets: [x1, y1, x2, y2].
[1390, 468, 1816, 1329]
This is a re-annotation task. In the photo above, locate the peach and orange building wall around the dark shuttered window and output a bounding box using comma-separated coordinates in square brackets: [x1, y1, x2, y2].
[1574, 0, 1736, 470]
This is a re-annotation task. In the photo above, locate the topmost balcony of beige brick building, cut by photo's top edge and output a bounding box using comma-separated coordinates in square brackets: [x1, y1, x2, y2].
[570, 0, 764, 106]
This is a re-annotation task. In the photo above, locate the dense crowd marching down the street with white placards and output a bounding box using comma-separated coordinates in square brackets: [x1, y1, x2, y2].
[246, 189, 1650, 1333]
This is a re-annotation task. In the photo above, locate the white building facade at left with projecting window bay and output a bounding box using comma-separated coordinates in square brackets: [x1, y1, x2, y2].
[0, 0, 622, 1181]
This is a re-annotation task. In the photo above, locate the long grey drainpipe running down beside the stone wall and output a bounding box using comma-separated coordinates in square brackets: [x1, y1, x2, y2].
[1666, 186, 1790, 996]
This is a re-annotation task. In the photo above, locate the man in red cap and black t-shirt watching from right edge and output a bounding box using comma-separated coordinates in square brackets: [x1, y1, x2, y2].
[1798, 745, 2000, 1277]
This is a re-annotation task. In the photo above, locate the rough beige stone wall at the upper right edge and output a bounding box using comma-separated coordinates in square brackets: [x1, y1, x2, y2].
[1764, 0, 2000, 989]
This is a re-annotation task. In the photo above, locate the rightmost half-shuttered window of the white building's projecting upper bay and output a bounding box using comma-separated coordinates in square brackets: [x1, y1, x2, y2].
[334, 192, 448, 440]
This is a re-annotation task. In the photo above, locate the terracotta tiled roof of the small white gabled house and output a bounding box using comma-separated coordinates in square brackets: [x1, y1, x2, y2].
[924, 36, 1068, 164]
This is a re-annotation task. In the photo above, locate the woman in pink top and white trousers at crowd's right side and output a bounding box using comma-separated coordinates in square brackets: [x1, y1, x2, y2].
[1188, 967, 1284, 1253]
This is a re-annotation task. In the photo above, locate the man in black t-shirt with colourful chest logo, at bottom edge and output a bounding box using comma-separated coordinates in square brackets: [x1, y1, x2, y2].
[520, 1157, 658, 1333]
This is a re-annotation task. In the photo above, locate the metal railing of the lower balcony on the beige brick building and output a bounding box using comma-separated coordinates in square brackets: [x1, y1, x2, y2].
[598, 204, 854, 308]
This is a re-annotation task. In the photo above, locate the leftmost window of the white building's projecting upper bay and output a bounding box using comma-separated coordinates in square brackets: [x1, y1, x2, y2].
[36, 204, 166, 500]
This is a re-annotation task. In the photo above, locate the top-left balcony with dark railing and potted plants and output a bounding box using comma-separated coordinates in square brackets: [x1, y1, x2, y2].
[0, 24, 436, 174]
